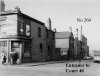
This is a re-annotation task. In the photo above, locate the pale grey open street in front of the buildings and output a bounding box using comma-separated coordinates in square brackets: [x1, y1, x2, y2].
[0, 60, 100, 76]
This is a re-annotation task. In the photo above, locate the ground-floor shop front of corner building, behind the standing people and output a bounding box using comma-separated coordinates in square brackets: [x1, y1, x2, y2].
[0, 39, 31, 64]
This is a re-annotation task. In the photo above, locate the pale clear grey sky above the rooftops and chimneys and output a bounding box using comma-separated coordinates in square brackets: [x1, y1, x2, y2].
[4, 0, 100, 54]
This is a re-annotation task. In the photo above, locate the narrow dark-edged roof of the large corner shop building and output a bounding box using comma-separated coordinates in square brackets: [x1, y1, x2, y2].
[1, 10, 44, 25]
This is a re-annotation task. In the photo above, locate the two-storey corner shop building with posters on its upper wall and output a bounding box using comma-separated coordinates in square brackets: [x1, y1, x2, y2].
[0, 10, 55, 63]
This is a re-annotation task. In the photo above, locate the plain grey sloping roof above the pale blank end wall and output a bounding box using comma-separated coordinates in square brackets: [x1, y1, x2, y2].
[55, 31, 71, 39]
